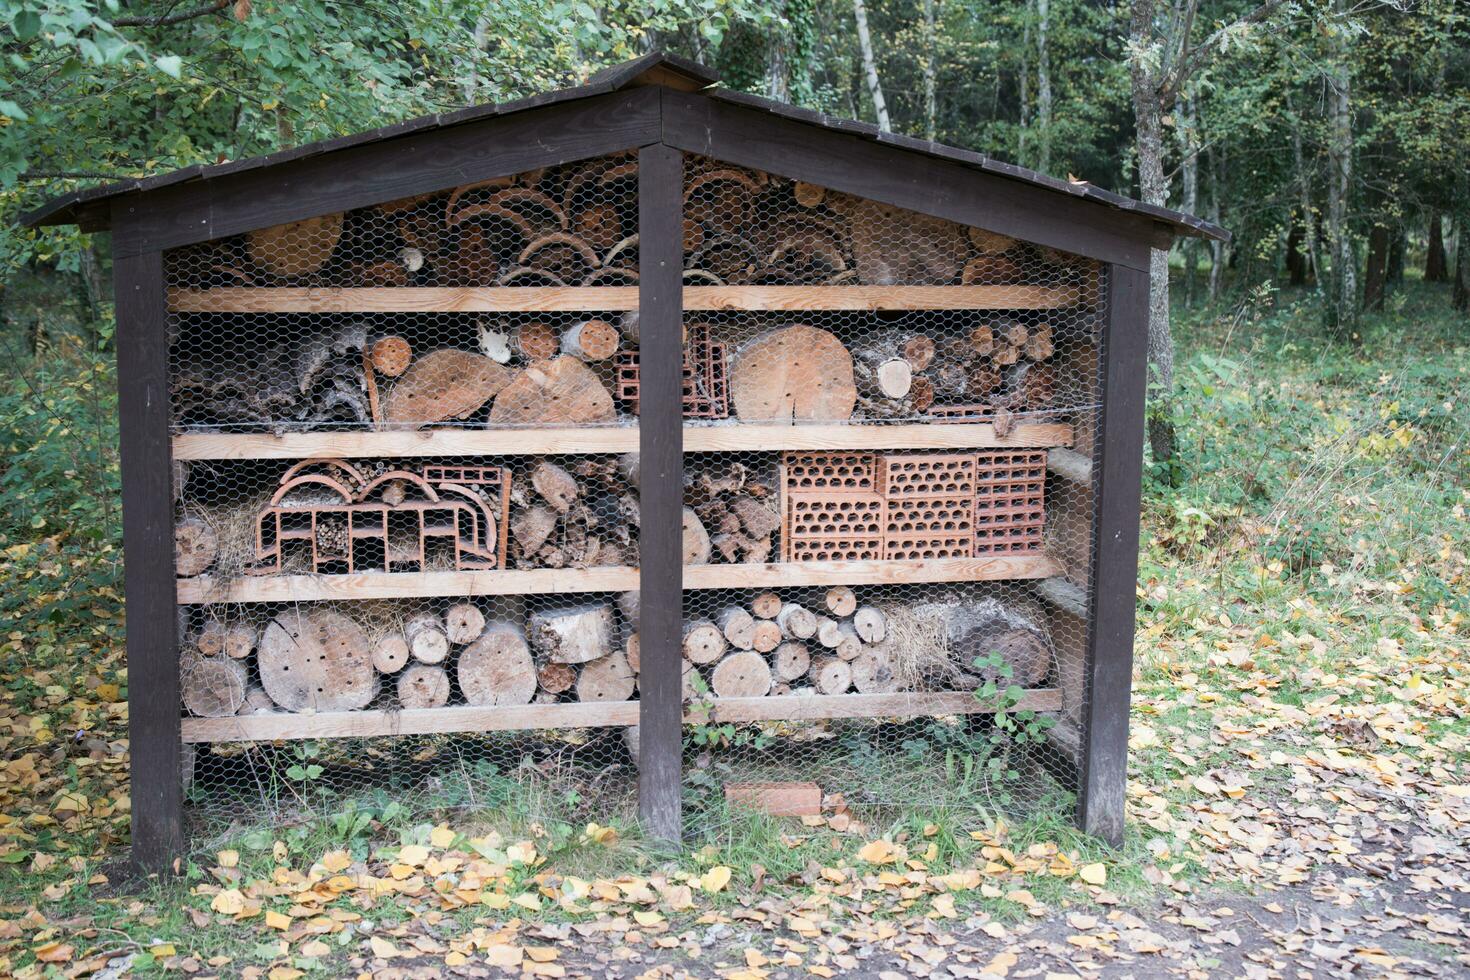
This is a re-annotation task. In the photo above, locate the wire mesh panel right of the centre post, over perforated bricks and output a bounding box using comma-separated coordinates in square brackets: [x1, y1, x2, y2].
[684, 157, 1104, 834]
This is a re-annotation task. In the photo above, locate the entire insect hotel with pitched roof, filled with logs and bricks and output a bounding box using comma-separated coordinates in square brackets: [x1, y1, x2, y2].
[26, 54, 1223, 868]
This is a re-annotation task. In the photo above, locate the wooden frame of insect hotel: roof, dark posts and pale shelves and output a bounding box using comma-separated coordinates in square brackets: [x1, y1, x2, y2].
[24, 54, 1225, 870]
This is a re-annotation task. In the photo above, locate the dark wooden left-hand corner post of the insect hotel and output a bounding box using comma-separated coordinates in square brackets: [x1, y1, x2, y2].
[113, 239, 184, 871]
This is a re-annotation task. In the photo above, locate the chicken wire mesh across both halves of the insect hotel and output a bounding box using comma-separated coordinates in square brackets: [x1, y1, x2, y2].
[166, 147, 1105, 846]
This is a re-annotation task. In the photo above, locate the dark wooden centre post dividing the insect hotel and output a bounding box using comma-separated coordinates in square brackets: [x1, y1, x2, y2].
[638, 144, 684, 840]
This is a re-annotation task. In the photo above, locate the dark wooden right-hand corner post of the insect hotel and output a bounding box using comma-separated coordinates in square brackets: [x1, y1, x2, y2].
[1078, 264, 1148, 845]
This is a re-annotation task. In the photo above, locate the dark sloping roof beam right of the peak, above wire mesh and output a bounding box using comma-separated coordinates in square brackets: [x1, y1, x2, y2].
[663, 91, 1155, 269]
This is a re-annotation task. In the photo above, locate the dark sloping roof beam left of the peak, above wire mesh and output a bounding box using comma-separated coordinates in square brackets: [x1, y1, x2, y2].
[103, 88, 659, 256]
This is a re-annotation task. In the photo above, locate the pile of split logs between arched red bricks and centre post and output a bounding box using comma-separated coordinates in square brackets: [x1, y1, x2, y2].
[509, 457, 639, 569]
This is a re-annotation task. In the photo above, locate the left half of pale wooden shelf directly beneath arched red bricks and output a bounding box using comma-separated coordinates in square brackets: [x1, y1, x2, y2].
[178, 566, 638, 605]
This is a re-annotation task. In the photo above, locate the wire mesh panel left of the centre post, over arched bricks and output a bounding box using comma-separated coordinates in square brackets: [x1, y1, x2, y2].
[166, 153, 639, 820]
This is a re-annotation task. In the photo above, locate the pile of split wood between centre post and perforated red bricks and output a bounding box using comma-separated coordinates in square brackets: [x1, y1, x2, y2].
[684, 463, 781, 564]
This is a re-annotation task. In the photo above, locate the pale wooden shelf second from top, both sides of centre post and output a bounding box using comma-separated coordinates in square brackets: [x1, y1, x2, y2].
[173, 422, 1072, 460]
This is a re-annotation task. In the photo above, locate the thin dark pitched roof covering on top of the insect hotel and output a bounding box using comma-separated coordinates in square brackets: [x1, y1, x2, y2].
[21, 51, 1229, 241]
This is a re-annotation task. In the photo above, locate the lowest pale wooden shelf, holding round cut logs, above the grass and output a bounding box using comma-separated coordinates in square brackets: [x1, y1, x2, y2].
[181, 688, 1061, 742]
